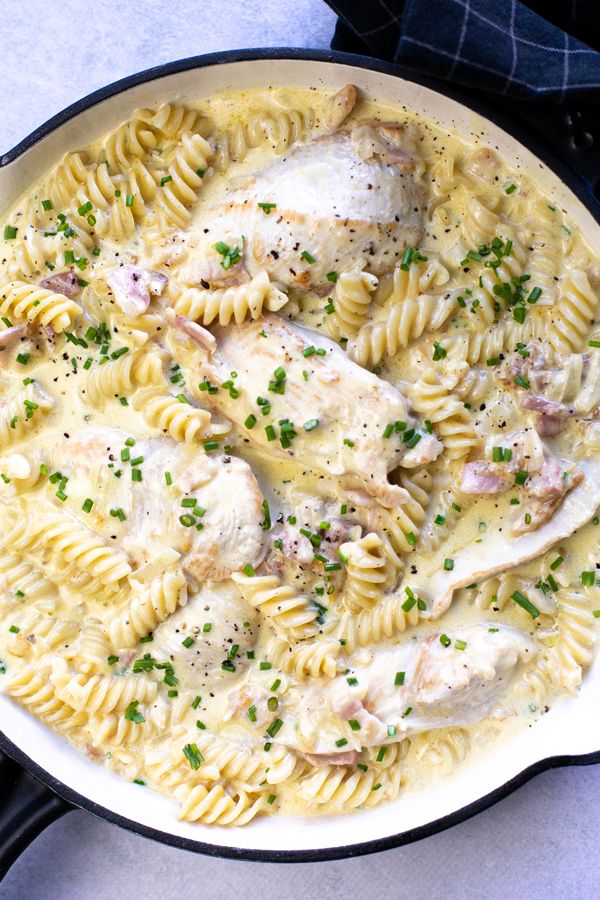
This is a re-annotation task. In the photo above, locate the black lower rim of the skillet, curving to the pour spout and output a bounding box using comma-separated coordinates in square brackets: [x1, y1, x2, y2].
[0, 732, 600, 863]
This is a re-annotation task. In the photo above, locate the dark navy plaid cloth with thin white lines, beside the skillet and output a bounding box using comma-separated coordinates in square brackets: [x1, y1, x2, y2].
[327, 0, 600, 105]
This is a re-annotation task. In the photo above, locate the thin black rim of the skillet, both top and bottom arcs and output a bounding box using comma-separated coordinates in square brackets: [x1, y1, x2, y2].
[0, 47, 600, 863]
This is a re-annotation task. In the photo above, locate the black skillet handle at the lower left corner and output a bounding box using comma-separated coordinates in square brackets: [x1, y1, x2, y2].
[0, 752, 73, 881]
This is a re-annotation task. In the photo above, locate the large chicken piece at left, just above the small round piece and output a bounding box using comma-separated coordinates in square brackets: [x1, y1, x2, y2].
[44, 427, 264, 581]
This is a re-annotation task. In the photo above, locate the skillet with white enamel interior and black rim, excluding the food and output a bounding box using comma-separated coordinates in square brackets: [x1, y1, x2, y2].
[0, 49, 600, 877]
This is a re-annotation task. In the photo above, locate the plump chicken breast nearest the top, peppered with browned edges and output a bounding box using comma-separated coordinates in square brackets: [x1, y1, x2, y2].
[171, 123, 424, 288]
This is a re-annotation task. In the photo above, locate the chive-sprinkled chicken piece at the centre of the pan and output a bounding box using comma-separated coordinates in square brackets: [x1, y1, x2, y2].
[169, 315, 441, 506]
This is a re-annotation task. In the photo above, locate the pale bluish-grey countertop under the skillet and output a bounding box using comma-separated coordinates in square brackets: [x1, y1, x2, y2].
[0, 0, 600, 900]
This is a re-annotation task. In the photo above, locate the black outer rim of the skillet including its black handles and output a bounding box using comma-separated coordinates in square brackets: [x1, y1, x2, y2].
[0, 48, 600, 878]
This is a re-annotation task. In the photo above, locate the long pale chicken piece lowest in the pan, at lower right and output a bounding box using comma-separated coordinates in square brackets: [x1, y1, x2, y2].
[238, 623, 537, 764]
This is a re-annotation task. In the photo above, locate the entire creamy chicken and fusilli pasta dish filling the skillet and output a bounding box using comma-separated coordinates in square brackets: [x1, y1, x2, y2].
[0, 85, 600, 825]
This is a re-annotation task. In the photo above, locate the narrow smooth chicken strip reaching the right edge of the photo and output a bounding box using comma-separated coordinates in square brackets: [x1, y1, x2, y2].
[420, 459, 600, 619]
